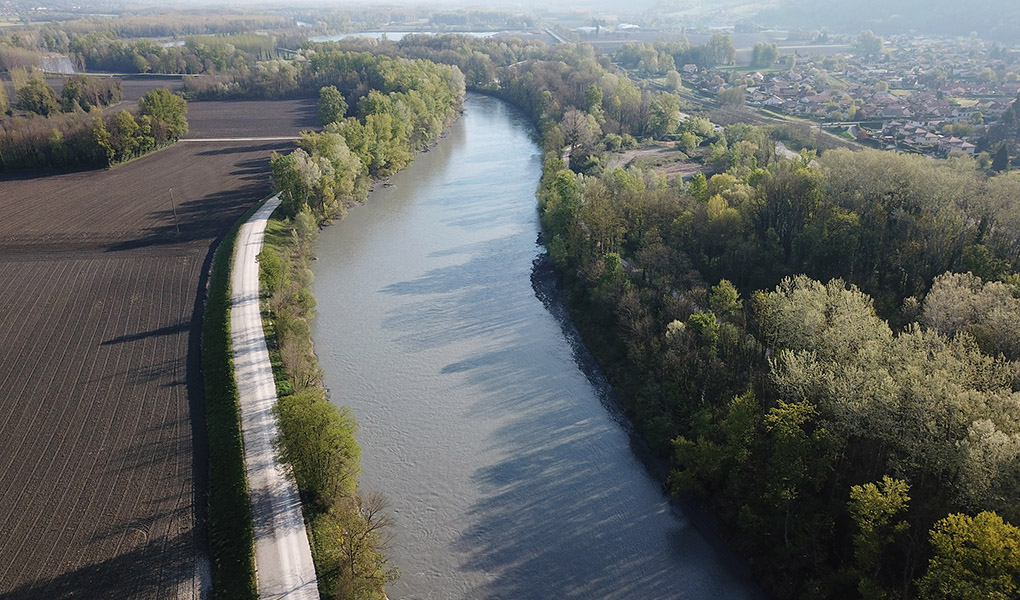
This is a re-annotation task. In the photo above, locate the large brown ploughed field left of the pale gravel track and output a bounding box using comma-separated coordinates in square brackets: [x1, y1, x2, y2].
[0, 102, 304, 600]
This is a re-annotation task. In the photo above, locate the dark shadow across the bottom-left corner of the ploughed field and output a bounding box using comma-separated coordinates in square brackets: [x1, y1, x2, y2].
[0, 528, 198, 600]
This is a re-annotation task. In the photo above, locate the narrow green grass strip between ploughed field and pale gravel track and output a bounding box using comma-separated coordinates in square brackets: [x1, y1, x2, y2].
[202, 202, 262, 600]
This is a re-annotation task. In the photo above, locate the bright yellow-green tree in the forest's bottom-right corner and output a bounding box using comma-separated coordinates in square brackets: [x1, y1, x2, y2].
[918, 512, 1020, 600]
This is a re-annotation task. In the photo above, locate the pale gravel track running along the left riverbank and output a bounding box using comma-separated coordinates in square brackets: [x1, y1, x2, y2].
[231, 197, 319, 600]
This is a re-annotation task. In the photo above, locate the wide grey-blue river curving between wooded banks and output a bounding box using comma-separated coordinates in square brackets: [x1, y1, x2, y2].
[313, 96, 756, 600]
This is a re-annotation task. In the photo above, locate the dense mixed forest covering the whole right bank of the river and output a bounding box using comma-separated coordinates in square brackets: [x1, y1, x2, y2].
[334, 31, 1020, 598]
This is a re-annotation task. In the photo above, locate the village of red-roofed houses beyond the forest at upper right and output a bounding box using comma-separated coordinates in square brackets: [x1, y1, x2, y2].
[677, 36, 1020, 159]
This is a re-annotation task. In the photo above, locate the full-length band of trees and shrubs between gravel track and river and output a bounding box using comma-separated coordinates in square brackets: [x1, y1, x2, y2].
[259, 52, 464, 599]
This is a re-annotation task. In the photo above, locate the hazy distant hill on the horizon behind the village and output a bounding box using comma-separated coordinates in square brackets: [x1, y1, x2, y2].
[749, 0, 1020, 44]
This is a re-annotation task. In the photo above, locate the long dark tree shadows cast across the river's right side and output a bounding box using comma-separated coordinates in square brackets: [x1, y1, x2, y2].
[371, 235, 758, 599]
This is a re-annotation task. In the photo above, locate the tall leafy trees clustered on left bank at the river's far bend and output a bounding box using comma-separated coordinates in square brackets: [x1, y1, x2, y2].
[271, 52, 464, 219]
